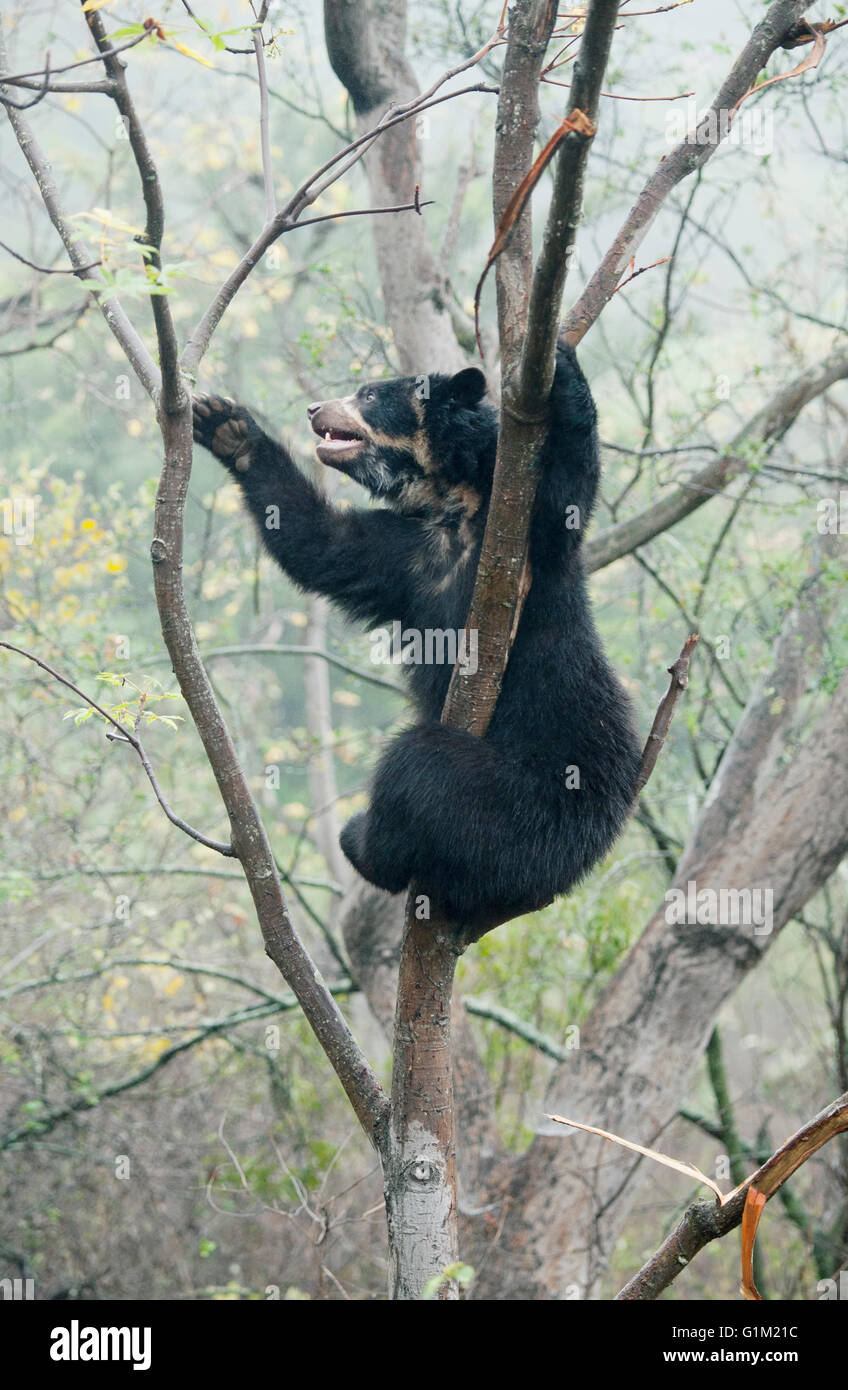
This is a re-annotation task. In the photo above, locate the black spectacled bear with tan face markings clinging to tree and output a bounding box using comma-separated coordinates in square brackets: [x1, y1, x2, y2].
[195, 348, 639, 926]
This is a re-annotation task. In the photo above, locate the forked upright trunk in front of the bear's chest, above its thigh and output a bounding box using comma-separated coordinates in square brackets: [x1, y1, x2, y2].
[442, 0, 619, 735]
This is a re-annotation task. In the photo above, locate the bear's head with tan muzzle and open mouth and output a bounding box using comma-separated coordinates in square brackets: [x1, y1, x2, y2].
[307, 367, 498, 514]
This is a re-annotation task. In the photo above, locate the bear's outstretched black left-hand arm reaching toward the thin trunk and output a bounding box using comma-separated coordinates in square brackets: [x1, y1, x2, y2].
[195, 395, 421, 624]
